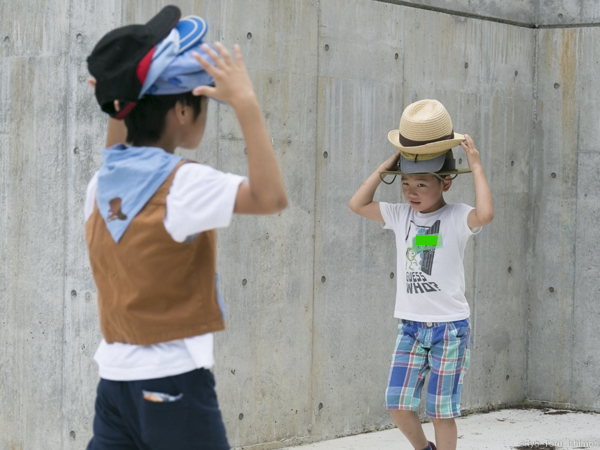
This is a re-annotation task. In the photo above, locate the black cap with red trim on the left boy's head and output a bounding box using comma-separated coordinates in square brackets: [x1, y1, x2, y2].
[87, 5, 181, 119]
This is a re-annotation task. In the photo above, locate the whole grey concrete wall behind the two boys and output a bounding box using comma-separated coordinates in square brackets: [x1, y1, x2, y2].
[0, 0, 600, 450]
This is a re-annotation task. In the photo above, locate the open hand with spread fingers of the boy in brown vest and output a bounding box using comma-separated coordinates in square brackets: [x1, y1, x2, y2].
[193, 42, 255, 108]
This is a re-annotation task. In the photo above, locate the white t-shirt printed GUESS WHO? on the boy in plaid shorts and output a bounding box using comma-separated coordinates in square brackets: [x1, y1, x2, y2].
[379, 202, 481, 322]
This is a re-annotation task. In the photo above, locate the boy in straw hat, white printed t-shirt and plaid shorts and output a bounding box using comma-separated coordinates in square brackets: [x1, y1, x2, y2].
[349, 100, 494, 450]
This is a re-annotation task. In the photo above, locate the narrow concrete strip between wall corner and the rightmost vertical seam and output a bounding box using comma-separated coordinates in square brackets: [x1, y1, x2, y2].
[528, 29, 580, 403]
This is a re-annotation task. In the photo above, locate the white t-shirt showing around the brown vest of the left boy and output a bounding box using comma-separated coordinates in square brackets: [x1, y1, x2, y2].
[85, 163, 247, 381]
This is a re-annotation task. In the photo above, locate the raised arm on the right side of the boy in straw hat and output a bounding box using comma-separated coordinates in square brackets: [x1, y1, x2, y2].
[460, 134, 494, 228]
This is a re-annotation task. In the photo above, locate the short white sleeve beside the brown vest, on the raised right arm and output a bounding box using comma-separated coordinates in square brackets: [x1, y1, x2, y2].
[165, 163, 247, 242]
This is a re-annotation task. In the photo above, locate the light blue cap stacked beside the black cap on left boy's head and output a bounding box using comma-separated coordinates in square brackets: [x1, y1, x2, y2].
[139, 16, 215, 98]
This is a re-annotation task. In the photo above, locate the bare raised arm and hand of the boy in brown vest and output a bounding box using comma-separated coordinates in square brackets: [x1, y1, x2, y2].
[194, 42, 287, 214]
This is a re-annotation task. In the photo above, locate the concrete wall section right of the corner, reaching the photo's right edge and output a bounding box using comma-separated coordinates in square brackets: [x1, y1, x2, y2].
[528, 24, 600, 410]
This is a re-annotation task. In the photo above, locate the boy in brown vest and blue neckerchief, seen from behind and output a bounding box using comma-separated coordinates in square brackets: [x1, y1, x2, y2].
[85, 6, 287, 450]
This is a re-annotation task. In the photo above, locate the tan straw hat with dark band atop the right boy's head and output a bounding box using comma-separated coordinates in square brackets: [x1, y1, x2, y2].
[388, 100, 465, 155]
